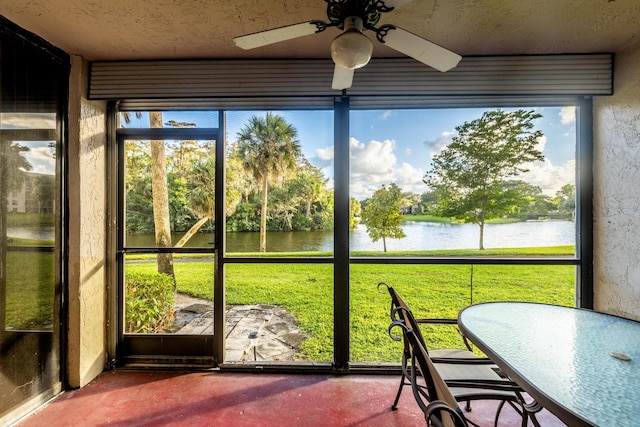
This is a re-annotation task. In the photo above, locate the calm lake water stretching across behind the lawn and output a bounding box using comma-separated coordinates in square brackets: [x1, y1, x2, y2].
[7, 221, 575, 252]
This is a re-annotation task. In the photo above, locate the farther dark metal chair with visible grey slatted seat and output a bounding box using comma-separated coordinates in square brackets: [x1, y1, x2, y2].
[378, 282, 539, 426]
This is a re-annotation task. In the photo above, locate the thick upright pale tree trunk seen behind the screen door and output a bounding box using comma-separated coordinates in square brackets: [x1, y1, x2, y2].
[149, 112, 174, 277]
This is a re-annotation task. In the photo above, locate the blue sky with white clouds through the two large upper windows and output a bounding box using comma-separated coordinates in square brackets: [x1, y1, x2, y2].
[227, 107, 576, 200]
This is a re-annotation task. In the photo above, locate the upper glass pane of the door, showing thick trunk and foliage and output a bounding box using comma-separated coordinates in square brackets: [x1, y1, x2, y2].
[125, 139, 215, 249]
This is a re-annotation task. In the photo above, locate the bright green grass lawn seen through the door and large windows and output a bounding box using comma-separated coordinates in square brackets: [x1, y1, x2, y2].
[127, 247, 575, 362]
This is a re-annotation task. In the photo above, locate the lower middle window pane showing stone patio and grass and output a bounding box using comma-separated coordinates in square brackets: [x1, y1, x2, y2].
[225, 264, 333, 362]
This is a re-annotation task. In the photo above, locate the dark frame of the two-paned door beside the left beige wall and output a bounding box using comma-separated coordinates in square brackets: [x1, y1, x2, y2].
[109, 114, 225, 367]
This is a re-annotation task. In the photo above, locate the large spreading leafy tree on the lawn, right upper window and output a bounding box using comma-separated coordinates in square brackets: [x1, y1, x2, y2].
[424, 109, 544, 250]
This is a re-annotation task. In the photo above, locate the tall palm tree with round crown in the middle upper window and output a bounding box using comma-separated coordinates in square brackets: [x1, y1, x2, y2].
[238, 112, 301, 252]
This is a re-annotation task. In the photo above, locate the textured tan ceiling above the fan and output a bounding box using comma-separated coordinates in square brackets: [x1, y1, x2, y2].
[0, 0, 640, 60]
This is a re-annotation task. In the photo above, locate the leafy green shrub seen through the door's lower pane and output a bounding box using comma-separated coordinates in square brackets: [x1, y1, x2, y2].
[125, 272, 175, 333]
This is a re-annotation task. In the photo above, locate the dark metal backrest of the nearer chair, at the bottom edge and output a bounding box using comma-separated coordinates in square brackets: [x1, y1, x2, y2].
[389, 316, 466, 427]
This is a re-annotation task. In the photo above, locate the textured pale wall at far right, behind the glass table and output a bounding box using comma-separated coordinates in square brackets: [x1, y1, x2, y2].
[593, 43, 640, 319]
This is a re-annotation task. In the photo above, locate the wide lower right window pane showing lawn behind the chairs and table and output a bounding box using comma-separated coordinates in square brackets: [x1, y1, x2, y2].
[350, 264, 575, 362]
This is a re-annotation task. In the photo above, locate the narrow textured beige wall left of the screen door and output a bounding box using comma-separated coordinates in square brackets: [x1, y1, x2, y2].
[67, 56, 107, 387]
